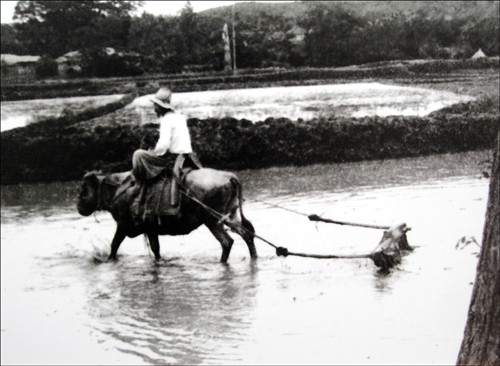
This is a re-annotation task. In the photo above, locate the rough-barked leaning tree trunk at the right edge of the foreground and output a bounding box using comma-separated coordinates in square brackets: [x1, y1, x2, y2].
[457, 130, 500, 365]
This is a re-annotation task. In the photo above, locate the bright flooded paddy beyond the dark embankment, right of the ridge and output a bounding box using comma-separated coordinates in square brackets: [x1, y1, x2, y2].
[131, 83, 473, 122]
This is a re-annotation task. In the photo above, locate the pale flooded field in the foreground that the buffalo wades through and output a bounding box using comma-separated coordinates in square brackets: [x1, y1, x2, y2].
[1, 152, 491, 364]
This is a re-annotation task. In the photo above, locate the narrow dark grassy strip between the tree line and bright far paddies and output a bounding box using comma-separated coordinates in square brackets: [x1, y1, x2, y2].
[0, 57, 500, 101]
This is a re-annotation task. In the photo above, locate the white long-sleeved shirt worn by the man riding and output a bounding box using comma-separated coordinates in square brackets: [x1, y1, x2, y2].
[154, 112, 193, 155]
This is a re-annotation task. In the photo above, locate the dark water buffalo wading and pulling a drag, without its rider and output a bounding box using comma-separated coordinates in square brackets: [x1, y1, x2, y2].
[77, 168, 257, 263]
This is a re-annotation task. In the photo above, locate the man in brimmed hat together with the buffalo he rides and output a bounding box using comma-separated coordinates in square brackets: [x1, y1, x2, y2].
[77, 88, 257, 262]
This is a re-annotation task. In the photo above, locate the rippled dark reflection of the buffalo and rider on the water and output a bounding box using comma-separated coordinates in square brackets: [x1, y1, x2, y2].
[88, 260, 257, 364]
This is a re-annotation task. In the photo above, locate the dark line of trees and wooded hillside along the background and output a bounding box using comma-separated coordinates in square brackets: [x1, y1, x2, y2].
[1, 1, 500, 76]
